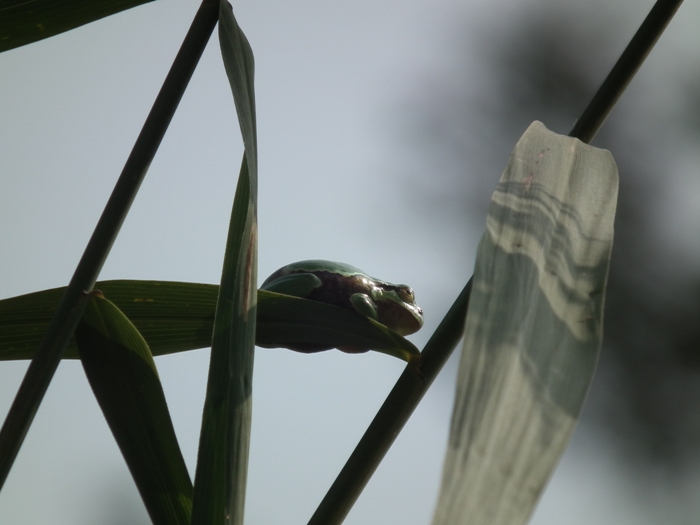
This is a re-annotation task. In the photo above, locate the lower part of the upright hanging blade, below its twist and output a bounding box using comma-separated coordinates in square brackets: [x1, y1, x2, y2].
[192, 159, 257, 525]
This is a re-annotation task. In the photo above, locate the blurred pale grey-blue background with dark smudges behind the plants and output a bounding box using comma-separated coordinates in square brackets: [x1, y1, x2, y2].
[0, 0, 700, 525]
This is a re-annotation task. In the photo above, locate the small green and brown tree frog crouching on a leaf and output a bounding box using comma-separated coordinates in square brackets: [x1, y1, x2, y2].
[260, 260, 423, 336]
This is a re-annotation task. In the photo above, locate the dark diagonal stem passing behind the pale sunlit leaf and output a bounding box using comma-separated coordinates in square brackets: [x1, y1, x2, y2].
[308, 0, 682, 525]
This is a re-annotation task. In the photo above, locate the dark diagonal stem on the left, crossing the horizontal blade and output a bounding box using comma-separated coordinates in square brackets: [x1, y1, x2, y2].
[0, 0, 219, 488]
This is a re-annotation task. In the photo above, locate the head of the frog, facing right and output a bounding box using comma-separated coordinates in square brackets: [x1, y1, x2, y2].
[371, 283, 423, 336]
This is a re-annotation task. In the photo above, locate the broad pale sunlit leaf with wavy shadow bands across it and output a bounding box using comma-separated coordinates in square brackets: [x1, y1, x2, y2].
[433, 122, 618, 525]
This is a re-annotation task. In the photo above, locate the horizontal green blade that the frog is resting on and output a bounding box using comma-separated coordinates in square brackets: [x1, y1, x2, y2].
[0, 280, 420, 361]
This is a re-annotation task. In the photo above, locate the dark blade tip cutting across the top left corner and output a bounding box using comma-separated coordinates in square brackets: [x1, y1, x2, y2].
[0, 0, 153, 53]
